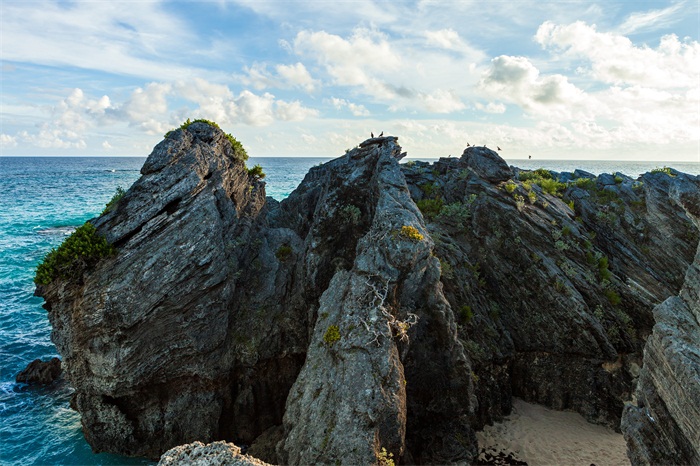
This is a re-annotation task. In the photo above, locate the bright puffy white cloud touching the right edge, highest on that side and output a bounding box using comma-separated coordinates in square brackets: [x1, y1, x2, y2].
[535, 21, 700, 88]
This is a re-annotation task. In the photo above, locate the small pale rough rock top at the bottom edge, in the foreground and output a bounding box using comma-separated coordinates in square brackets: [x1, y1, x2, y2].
[158, 442, 269, 466]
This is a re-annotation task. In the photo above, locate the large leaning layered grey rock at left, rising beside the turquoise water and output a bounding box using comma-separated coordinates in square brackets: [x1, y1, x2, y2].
[39, 123, 264, 457]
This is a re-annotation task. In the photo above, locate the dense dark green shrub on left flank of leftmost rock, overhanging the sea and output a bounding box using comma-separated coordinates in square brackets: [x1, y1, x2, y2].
[34, 223, 117, 285]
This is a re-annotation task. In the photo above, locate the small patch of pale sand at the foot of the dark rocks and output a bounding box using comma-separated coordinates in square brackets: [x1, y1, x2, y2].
[476, 398, 630, 466]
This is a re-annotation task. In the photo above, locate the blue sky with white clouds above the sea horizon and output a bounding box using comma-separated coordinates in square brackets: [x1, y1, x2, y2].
[0, 0, 700, 162]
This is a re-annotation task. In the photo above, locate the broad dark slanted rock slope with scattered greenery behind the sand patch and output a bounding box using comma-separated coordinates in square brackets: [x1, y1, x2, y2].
[403, 159, 698, 428]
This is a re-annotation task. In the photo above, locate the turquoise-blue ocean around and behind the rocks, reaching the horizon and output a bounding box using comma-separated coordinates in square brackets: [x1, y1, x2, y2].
[0, 157, 700, 465]
